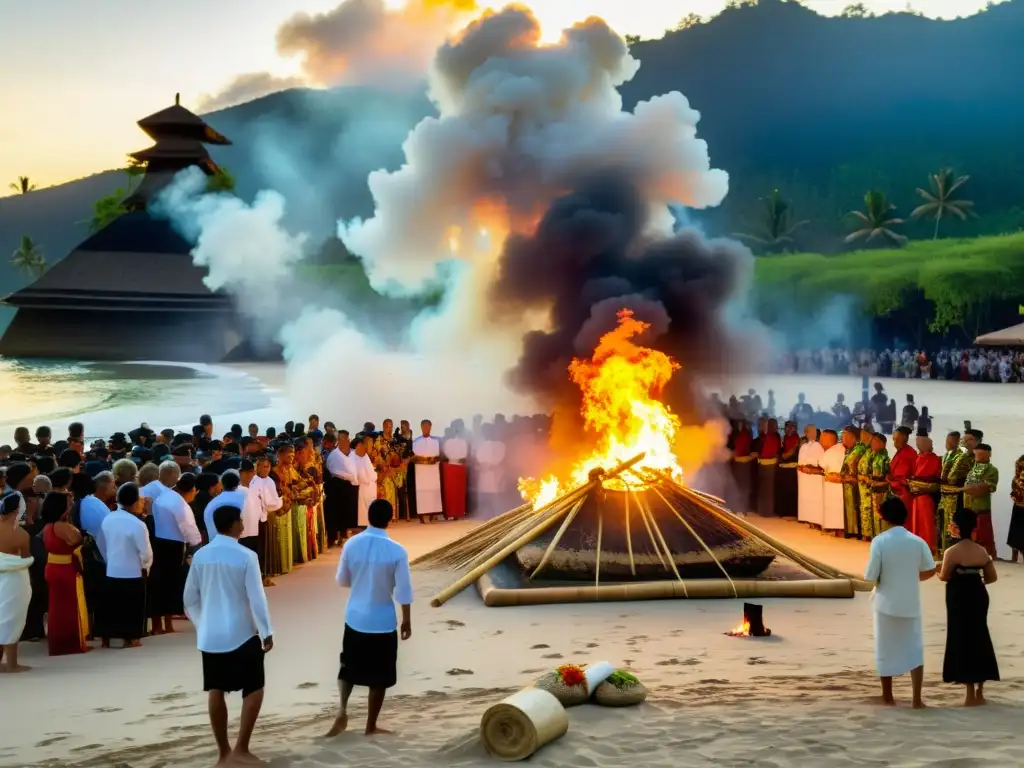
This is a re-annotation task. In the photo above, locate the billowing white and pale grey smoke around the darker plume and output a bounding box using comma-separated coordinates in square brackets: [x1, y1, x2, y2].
[168, 0, 728, 424]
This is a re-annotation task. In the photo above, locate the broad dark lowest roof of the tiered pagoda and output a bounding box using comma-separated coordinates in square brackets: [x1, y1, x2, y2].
[5, 211, 230, 311]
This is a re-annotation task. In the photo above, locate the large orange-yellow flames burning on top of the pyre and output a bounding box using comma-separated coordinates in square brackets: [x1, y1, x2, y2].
[519, 309, 683, 509]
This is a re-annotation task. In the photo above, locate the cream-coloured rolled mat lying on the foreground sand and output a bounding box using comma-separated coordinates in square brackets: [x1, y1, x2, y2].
[480, 688, 569, 762]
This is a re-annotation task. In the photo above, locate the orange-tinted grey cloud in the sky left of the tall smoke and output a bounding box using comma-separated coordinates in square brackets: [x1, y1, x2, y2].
[201, 0, 476, 111]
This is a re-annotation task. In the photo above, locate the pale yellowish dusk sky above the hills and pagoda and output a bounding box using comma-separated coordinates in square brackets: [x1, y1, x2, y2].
[0, 0, 1007, 195]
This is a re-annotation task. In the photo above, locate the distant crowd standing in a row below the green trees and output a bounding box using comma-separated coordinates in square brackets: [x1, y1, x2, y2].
[775, 347, 1024, 384]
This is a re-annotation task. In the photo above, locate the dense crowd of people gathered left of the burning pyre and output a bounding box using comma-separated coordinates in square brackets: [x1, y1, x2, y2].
[0, 415, 548, 672]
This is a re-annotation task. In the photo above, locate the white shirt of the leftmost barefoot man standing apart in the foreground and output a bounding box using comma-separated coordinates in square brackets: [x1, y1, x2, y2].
[184, 536, 273, 653]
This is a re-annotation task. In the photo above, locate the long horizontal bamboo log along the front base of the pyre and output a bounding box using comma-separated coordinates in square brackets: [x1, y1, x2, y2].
[476, 574, 854, 607]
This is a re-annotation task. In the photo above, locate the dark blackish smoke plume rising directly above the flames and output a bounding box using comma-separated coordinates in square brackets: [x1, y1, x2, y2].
[492, 173, 753, 413]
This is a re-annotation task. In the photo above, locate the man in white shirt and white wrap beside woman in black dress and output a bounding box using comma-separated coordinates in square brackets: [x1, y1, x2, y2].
[864, 497, 935, 710]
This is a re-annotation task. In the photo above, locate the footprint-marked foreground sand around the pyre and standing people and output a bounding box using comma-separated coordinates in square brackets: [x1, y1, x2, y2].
[0, 518, 1024, 768]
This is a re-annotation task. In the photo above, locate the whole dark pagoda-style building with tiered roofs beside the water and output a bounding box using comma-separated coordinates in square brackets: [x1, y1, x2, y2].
[0, 97, 246, 362]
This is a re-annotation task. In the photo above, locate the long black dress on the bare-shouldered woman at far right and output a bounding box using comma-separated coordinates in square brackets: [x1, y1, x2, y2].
[942, 567, 999, 685]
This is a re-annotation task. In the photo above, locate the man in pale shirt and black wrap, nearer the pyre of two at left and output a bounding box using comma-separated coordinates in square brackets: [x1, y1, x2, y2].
[327, 499, 413, 737]
